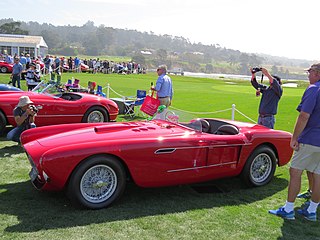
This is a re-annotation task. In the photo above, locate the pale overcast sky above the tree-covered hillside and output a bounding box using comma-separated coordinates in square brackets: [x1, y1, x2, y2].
[0, 0, 320, 60]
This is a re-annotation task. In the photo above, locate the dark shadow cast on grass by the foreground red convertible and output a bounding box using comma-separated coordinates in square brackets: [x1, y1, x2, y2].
[0, 174, 288, 232]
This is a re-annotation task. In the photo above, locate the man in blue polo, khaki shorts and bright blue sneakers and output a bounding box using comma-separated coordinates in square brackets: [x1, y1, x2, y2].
[269, 63, 320, 221]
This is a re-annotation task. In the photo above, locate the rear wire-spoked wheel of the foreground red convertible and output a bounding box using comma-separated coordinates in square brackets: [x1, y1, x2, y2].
[241, 146, 276, 187]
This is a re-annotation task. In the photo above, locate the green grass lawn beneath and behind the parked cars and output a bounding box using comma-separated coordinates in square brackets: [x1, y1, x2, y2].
[0, 73, 320, 240]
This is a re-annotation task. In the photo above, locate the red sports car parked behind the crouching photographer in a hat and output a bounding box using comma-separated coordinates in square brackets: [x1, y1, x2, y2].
[0, 85, 119, 132]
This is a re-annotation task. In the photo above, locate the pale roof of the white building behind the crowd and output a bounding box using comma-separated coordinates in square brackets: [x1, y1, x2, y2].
[0, 34, 48, 48]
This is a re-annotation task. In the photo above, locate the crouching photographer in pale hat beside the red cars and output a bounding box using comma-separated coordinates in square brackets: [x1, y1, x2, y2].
[7, 96, 37, 143]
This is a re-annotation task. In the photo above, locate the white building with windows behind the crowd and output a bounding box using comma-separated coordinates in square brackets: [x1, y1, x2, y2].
[0, 34, 48, 57]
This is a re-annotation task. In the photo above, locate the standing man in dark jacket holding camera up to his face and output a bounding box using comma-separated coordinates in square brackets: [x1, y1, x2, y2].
[250, 67, 283, 129]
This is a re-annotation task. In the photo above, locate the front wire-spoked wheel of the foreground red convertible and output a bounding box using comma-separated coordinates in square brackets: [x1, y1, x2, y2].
[67, 156, 126, 209]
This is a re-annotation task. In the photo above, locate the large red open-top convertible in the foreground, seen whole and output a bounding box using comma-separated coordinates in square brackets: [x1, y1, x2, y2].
[21, 119, 292, 209]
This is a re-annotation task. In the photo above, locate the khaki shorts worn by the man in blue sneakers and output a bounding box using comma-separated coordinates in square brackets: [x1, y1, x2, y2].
[291, 143, 320, 174]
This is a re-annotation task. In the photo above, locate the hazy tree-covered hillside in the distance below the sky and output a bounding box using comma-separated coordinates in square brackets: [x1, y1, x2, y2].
[0, 19, 311, 78]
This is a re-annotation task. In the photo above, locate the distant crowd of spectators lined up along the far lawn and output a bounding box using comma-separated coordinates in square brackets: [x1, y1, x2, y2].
[0, 53, 146, 90]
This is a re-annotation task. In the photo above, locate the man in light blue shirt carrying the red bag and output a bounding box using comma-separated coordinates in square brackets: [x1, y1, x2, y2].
[151, 65, 173, 107]
